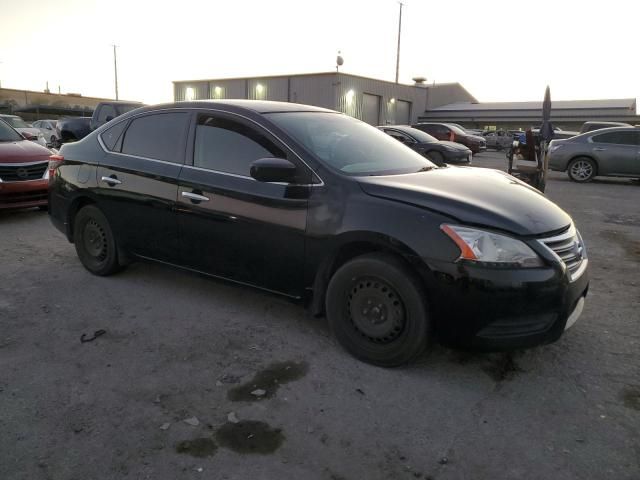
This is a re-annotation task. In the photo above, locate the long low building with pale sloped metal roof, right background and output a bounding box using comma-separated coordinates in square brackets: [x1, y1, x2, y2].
[420, 98, 640, 130]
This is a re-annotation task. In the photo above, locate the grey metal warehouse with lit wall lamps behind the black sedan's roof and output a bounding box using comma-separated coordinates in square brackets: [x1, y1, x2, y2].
[173, 72, 477, 125]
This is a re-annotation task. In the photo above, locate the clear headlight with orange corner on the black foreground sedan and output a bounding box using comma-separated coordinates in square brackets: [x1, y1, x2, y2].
[440, 225, 543, 267]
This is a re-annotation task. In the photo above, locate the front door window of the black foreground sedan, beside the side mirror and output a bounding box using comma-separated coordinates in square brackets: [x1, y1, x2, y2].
[193, 115, 286, 177]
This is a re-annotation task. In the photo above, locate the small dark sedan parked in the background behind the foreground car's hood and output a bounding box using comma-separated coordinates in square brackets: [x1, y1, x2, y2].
[378, 125, 472, 166]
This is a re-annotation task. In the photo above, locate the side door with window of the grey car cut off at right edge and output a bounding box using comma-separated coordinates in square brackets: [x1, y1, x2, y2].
[591, 128, 640, 175]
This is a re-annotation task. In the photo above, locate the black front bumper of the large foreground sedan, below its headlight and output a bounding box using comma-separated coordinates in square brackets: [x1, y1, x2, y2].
[424, 258, 589, 350]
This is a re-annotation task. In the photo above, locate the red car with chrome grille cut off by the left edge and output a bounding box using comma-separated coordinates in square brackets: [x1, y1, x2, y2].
[0, 120, 51, 209]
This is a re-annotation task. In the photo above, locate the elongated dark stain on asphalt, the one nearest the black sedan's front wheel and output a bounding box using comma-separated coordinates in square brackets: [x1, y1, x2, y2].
[227, 362, 309, 402]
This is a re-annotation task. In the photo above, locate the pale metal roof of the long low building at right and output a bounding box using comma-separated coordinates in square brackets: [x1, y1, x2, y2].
[430, 98, 636, 112]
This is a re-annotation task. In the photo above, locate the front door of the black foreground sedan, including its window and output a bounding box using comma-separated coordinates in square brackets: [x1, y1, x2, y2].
[178, 112, 311, 296]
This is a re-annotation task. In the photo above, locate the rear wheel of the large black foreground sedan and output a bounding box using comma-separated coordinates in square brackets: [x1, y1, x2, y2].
[73, 205, 122, 276]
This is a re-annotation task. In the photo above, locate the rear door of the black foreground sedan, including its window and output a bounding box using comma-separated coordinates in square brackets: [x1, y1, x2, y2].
[97, 110, 191, 262]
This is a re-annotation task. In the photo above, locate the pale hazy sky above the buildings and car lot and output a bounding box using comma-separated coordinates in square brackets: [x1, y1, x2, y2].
[0, 0, 640, 109]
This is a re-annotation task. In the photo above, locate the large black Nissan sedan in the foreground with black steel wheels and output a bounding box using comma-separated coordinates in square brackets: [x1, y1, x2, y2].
[49, 100, 589, 366]
